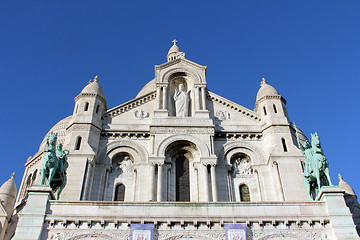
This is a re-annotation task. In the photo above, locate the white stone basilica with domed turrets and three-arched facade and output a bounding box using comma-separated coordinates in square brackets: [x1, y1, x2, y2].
[0, 41, 360, 240]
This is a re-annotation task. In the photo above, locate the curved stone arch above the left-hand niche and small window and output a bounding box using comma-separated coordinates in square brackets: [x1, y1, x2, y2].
[97, 140, 148, 164]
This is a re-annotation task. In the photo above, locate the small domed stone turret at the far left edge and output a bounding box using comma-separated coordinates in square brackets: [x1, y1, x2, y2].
[0, 173, 17, 216]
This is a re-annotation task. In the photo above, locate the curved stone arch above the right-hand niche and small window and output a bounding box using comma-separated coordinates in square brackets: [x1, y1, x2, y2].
[216, 141, 266, 165]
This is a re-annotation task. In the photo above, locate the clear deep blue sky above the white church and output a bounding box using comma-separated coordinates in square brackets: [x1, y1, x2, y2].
[0, 0, 360, 197]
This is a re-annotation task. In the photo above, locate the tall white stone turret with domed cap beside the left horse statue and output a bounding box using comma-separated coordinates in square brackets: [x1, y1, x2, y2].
[60, 76, 107, 200]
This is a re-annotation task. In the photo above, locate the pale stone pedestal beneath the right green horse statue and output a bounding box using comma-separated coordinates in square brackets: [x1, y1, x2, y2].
[316, 187, 359, 240]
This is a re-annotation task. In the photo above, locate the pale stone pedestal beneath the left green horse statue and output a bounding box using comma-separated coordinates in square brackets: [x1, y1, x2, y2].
[13, 185, 55, 240]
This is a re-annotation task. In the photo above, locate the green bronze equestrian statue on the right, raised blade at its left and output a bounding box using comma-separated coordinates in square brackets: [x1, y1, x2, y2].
[294, 124, 333, 200]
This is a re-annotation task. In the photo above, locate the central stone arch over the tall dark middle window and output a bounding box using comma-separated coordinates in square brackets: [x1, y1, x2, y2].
[155, 134, 210, 157]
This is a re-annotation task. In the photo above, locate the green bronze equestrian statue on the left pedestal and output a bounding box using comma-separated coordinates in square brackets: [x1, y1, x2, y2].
[40, 133, 69, 200]
